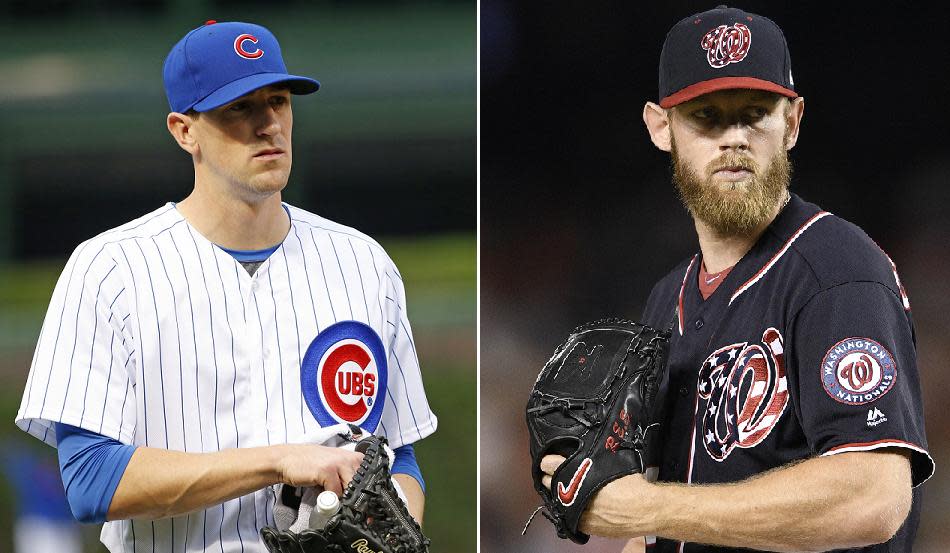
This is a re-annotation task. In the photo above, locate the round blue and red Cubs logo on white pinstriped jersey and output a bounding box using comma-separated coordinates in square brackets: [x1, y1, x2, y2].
[300, 321, 389, 432]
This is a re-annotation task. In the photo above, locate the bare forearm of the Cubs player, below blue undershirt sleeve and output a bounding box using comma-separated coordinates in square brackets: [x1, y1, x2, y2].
[108, 446, 283, 520]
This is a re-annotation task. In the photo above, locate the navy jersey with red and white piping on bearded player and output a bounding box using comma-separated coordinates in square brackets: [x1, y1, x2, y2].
[644, 195, 934, 553]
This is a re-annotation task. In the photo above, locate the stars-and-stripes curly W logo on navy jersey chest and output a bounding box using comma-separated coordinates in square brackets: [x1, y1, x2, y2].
[697, 328, 788, 462]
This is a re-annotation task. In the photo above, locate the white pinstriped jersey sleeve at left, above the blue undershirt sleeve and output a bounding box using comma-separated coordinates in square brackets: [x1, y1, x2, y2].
[16, 238, 135, 446]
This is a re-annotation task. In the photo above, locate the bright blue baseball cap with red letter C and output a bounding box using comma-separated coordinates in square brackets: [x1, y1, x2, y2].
[162, 20, 320, 113]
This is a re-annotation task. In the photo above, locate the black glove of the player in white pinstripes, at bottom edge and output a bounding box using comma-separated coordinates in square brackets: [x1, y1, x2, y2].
[261, 436, 429, 553]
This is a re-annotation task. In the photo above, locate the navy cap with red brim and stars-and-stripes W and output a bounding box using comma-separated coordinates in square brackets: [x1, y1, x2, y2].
[660, 6, 798, 108]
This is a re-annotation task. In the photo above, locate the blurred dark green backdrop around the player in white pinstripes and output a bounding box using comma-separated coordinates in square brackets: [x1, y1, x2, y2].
[0, 0, 477, 553]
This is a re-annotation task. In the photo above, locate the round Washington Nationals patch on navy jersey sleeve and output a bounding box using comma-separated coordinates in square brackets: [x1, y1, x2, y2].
[821, 338, 897, 405]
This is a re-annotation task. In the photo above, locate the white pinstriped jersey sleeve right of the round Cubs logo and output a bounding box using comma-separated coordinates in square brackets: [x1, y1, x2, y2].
[382, 257, 438, 449]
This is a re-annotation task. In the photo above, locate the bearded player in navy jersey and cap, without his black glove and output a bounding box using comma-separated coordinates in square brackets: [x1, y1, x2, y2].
[541, 6, 934, 553]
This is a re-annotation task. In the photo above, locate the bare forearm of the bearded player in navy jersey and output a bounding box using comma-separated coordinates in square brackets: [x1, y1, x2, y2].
[644, 452, 911, 551]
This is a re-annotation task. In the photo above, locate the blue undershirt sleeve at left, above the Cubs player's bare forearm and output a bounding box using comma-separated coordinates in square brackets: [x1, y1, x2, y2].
[56, 423, 135, 523]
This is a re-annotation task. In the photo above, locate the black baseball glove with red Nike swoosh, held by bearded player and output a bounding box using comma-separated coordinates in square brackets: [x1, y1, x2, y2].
[522, 319, 670, 543]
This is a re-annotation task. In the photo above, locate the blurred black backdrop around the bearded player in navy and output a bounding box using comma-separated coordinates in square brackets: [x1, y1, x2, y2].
[480, 0, 950, 553]
